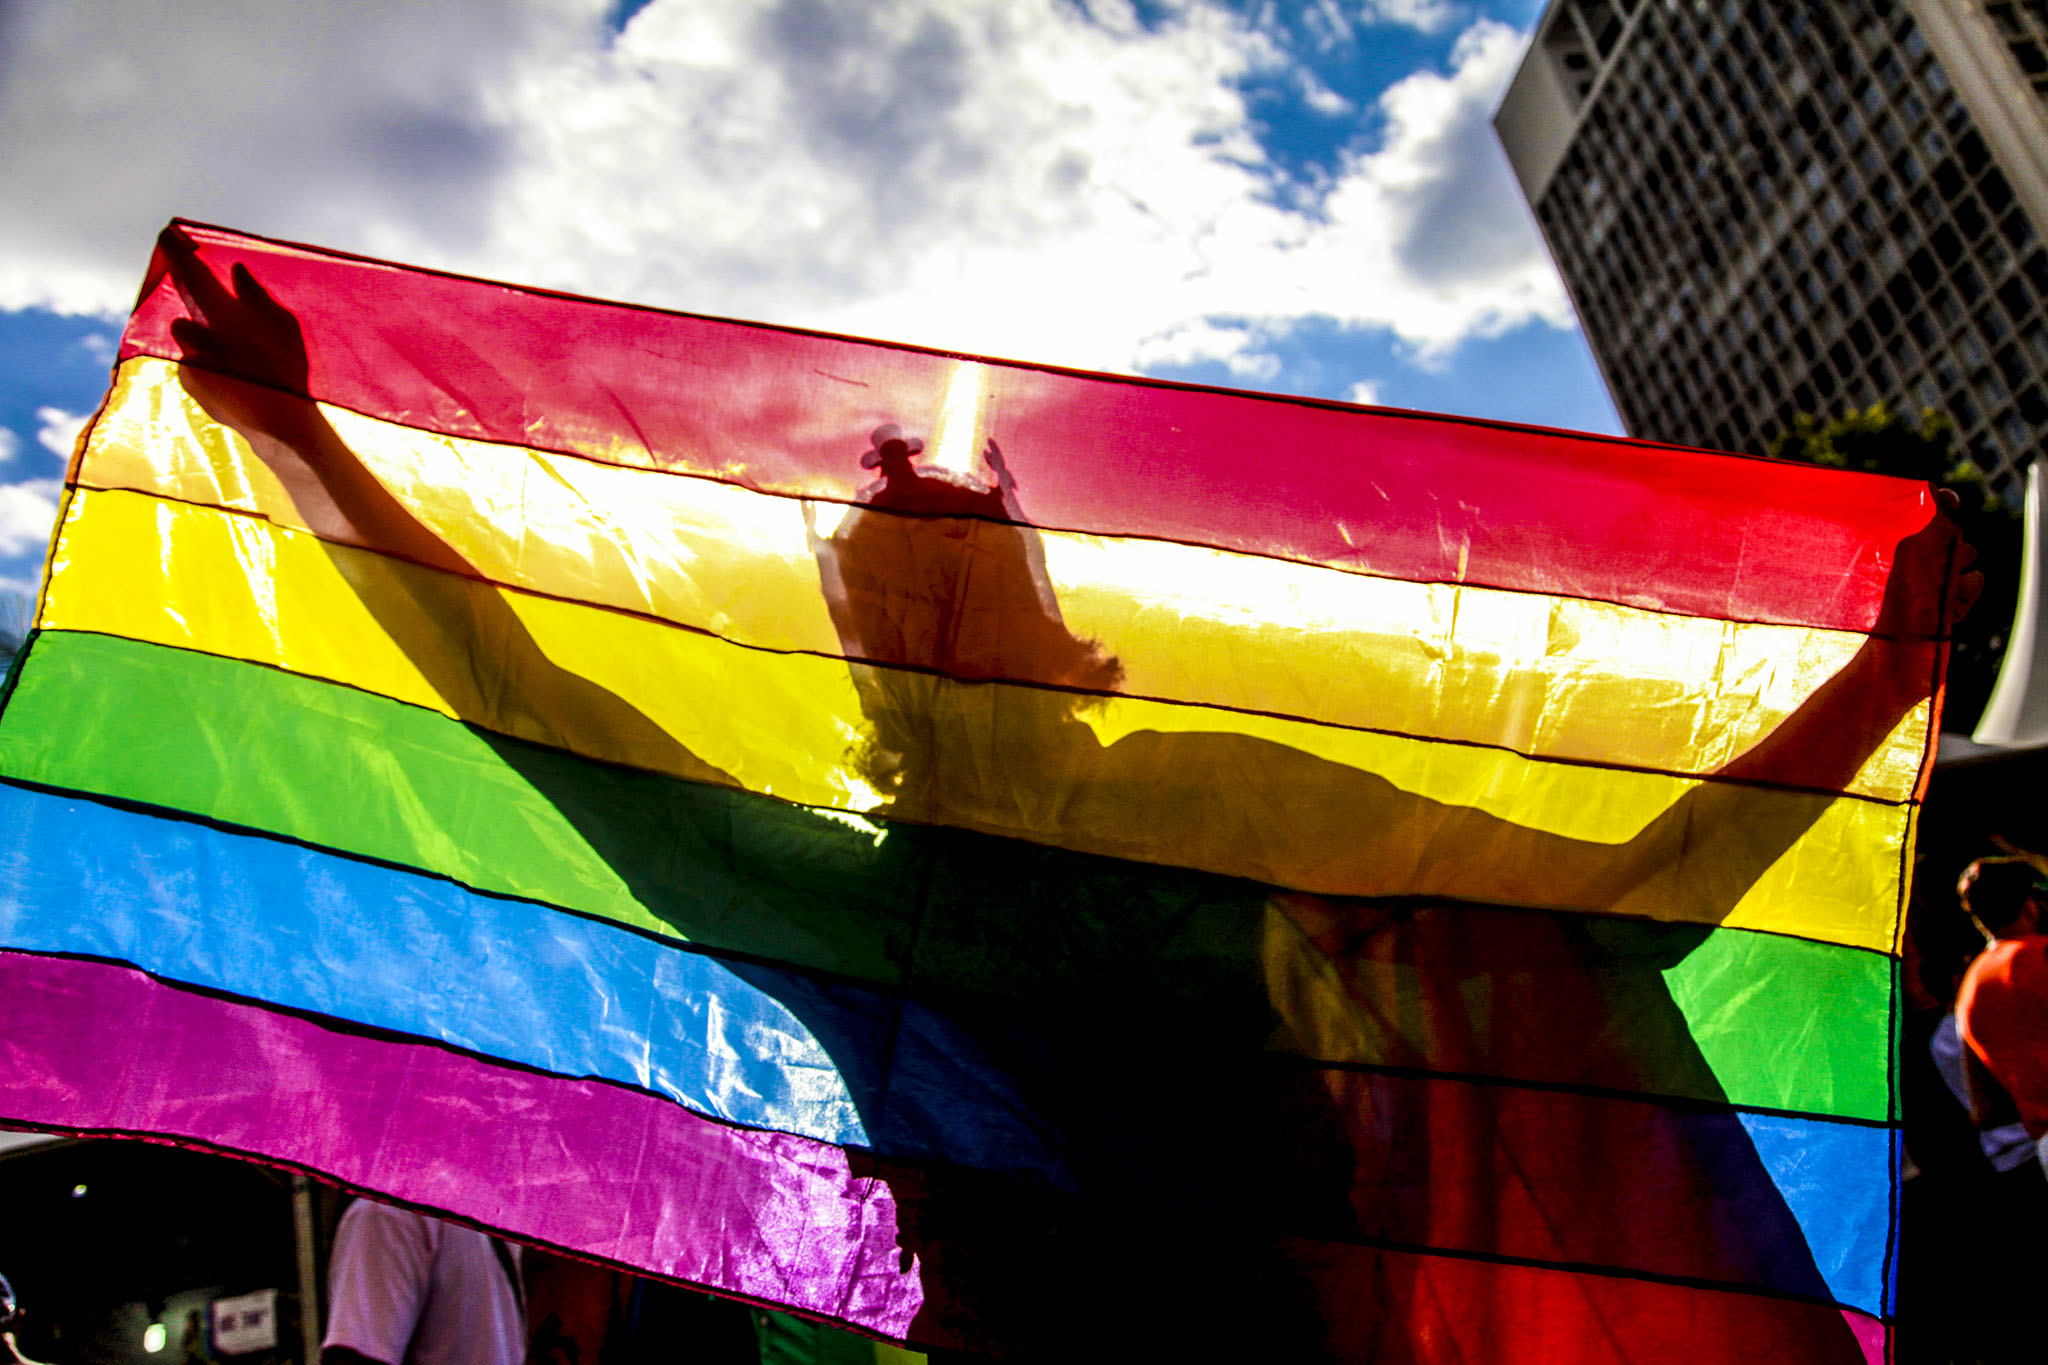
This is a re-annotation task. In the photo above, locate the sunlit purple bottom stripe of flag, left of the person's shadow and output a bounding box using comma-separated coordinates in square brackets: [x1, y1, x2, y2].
[0, 952, 924, 1336]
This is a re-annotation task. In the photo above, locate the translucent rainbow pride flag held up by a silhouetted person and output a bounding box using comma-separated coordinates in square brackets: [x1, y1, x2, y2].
[0, 223, 1956, 1365]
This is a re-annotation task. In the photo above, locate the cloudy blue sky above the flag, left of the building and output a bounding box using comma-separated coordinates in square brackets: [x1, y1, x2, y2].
[0, 0, 1618, 587]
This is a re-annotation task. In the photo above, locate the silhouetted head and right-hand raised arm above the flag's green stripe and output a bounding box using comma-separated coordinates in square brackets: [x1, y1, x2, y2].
[817, 417, 1980, 923]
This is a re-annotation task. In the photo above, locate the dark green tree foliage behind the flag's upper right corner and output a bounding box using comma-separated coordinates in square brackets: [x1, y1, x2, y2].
[1769, 403, 2021, 731]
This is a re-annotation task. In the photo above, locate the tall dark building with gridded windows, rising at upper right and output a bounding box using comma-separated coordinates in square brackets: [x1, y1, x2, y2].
[1495, 0, 2048, 497]
